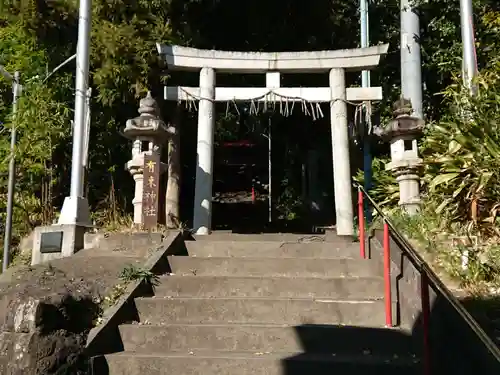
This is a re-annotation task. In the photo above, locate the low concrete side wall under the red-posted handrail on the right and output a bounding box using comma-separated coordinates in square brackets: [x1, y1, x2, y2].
[369, 230, 500, 375]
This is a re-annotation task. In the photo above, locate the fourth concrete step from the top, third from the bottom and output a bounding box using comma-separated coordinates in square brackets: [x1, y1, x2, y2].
[135, 298, 385, 327]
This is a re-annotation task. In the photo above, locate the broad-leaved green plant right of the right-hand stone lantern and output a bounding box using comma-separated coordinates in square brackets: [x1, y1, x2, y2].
[423, 70, 500, 230]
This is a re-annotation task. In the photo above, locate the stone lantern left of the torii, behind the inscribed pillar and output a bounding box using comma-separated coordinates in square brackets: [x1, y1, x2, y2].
[123, 92, 170, 225]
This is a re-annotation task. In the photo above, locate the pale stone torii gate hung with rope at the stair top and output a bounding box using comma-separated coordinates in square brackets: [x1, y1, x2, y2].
[157, 43, 388, 236]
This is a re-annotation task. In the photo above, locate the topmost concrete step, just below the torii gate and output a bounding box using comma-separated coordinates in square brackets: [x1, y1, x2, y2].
[186, 241, 359, 259]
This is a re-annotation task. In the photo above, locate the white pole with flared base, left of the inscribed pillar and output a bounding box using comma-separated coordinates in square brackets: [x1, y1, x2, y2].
[58, 0, 92, 226]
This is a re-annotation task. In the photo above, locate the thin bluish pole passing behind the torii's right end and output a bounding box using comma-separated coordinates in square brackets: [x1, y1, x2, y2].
[359, 0, 373, 222]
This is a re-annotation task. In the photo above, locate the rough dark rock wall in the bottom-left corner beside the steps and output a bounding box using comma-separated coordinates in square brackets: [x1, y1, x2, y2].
[0, 293, 99, 375]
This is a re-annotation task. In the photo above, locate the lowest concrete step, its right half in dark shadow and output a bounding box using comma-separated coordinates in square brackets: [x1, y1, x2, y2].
[92, 352, 422, 375]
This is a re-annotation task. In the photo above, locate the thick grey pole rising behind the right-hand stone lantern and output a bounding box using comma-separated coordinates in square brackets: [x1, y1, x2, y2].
[400, 0, 424, 118]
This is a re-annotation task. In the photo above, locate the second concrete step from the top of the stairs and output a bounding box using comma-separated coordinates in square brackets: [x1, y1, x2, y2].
[168, 256, 383, 277]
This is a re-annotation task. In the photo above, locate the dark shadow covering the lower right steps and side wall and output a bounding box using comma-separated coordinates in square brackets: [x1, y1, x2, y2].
[281, 286, 500, 375]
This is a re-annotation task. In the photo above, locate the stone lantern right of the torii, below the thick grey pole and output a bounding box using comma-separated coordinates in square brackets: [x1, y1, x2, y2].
[374, 99, 425, 215]
